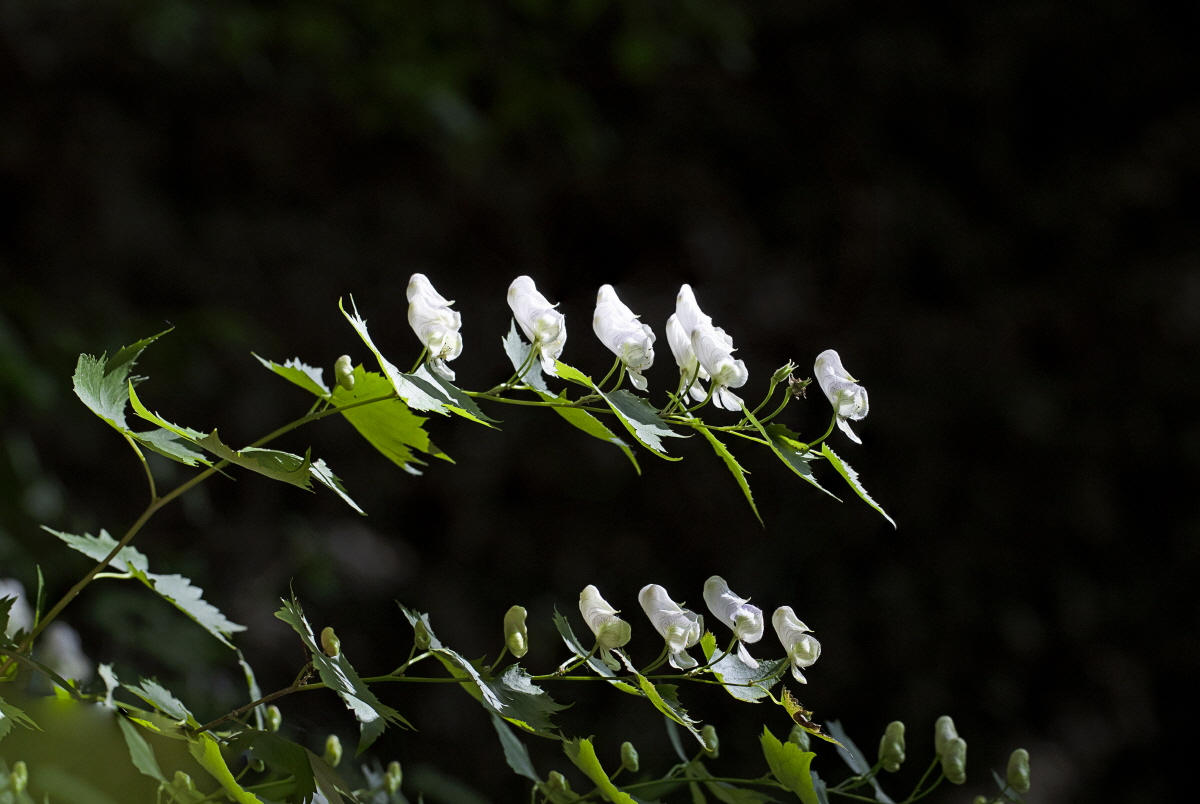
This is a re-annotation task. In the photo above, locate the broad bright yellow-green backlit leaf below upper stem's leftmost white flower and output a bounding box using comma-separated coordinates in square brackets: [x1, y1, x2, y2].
[332, 365, 454, 474]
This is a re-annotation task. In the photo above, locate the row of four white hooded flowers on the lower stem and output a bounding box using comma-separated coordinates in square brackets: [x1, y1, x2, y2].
[580, 575, 821, 684]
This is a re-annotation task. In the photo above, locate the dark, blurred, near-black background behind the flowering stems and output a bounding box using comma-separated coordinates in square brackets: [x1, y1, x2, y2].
[0, 0, 1200, 804]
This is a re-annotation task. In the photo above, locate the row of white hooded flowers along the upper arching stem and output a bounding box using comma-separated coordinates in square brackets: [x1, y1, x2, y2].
[408, 274, 868, 444]
